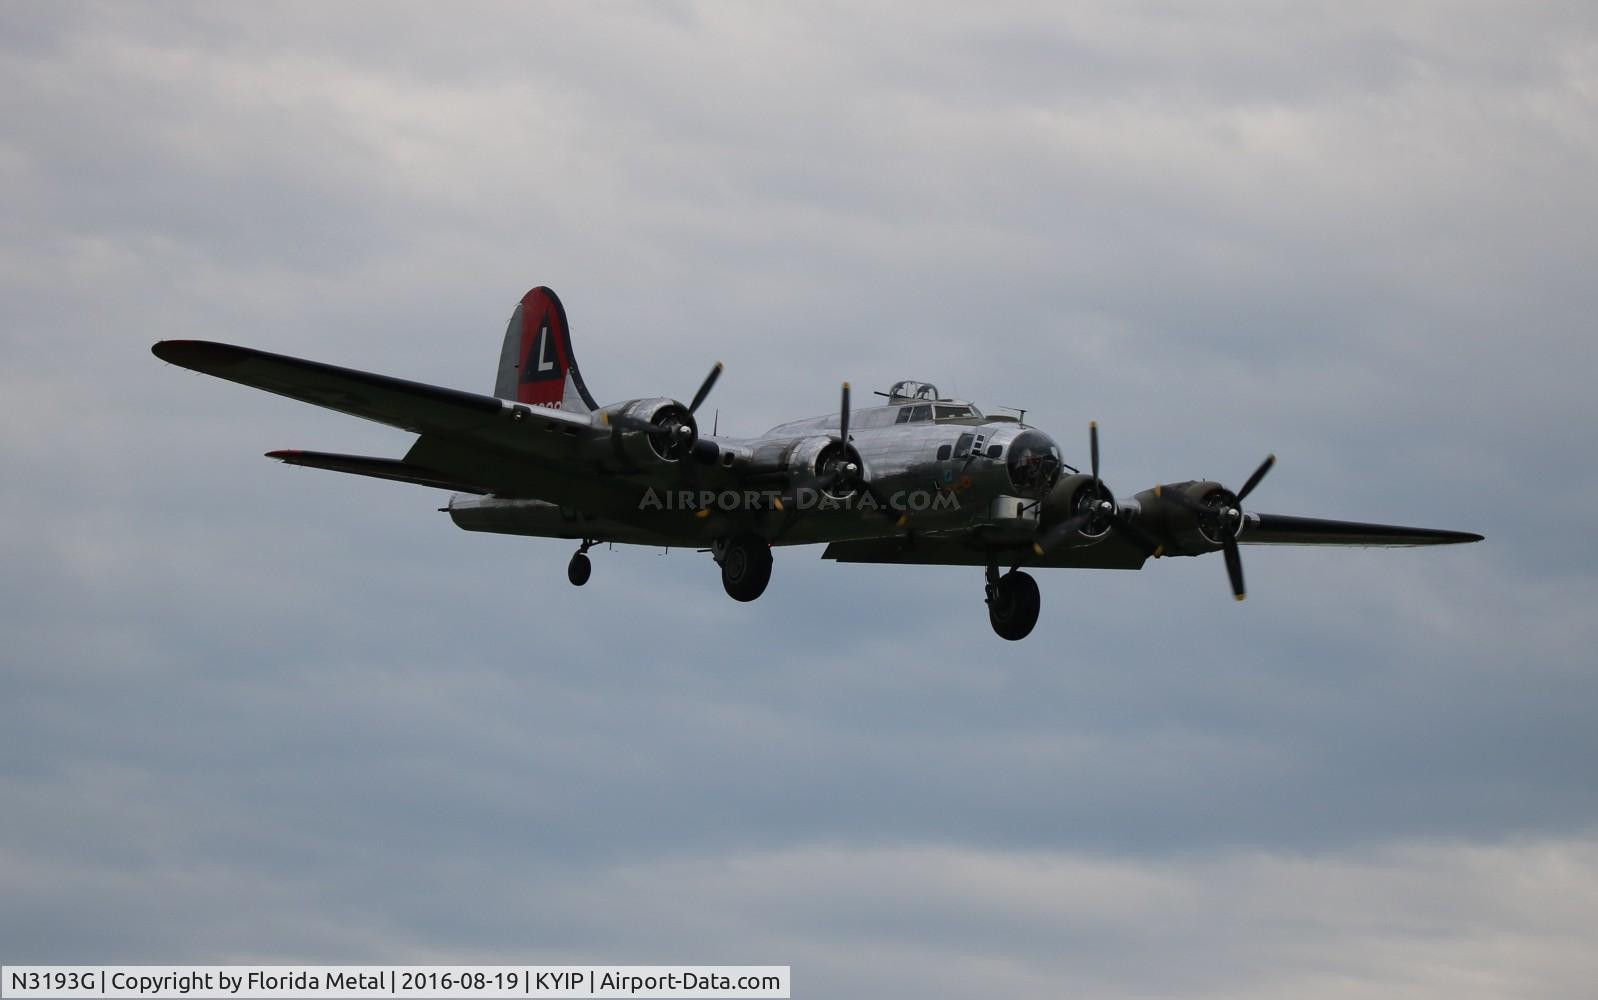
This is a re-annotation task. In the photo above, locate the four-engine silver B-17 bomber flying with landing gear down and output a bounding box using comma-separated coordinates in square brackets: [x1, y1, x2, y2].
[152, 288, 1481, 639]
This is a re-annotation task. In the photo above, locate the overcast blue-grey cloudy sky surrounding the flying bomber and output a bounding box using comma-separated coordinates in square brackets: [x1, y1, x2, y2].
[0, 2, 1598, 998]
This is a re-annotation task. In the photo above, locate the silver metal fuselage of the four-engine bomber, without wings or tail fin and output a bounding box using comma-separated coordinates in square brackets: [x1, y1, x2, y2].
[446, 401, 1058, 548]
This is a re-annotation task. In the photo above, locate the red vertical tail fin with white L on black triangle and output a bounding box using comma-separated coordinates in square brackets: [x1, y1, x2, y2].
[494, 284, 599, 414]
